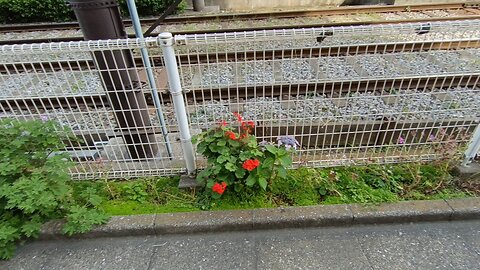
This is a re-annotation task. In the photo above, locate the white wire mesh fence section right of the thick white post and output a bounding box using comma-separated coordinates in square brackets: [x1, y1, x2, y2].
[176, 21, 480, 166]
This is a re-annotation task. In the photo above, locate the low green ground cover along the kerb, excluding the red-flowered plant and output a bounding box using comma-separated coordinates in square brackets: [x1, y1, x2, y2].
[66, 160, 480, 215]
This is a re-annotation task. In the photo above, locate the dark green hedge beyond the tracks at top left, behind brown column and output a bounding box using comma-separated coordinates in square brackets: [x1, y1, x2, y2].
[0, 0, 185, 23]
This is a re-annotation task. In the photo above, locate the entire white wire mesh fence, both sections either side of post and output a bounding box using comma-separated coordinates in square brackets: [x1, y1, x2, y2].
[0, 21, 480, 179]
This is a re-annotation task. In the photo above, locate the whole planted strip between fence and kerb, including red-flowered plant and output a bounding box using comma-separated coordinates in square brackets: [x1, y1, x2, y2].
[66, 113, 480, 215]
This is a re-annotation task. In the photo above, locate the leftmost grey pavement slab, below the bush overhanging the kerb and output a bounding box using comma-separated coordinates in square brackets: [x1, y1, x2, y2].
[0, 237, 155, 270]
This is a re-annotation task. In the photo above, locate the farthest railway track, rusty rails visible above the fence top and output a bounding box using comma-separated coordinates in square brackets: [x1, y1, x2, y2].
[0, 3, 480, 45]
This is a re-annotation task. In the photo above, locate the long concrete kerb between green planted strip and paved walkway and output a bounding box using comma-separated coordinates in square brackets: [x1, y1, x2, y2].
[39, 198, 480, 240]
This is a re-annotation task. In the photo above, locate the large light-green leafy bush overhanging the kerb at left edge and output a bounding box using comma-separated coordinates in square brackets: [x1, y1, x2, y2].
[0, 119, 107, 259]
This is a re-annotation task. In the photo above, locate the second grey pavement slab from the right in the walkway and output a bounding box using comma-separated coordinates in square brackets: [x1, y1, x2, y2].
[256, 228, 371, 270]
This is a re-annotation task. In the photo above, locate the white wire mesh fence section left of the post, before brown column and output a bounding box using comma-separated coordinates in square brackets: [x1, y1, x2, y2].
[0, 39, 185, 179]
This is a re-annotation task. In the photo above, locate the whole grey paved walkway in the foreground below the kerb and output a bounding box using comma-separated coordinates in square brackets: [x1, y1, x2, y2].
[0, 220, 480, 270]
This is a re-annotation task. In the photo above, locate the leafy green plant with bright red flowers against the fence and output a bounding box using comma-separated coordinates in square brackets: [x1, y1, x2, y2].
[194, 113, 292, 208]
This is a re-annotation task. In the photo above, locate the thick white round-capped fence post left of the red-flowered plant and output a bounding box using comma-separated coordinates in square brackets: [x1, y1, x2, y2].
[158, 33, 195, 174]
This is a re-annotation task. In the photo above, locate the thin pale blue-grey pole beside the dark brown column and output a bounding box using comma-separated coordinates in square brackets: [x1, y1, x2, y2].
[127, 0, 172, 159]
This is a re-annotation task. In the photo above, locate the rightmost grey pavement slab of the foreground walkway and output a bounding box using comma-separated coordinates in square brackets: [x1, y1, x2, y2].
[355, 221, 480, 270]
